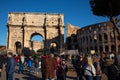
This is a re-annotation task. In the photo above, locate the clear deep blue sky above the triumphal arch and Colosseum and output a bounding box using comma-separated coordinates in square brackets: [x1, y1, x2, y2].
[0, 0, 108, 45]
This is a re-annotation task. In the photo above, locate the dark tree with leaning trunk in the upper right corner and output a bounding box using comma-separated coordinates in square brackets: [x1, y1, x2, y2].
[90, 0, 120, 51]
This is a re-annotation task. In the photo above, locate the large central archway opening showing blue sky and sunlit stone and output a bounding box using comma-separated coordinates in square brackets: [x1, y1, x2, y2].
[30, 33, 44, 52]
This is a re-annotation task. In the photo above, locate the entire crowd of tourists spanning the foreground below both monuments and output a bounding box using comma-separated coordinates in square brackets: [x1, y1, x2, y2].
[0, 52, 120, 80]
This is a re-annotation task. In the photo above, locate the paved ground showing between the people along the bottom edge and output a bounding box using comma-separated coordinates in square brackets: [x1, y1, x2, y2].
[0, 67, 76, 80]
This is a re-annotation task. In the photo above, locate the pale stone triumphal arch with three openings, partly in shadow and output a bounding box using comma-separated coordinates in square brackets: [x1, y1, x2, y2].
[7, 12, 64, 53]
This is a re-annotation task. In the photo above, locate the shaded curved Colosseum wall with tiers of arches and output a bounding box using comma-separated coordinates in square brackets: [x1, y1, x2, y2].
[77, 22, 120, 53]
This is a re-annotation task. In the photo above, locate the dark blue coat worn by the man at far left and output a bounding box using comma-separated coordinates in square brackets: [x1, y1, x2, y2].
[6, 57, 16, 74]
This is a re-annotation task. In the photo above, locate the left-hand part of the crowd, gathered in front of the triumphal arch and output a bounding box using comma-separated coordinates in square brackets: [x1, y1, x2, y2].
[0, 52, 68, 80]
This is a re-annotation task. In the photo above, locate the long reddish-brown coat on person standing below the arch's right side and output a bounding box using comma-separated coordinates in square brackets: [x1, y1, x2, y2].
[45, 57, 56, 78]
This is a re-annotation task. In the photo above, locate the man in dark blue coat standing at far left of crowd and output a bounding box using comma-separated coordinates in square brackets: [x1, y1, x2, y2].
[6, 52, 16, 80]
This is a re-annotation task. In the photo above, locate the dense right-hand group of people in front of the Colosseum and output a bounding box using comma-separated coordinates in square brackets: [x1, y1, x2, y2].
[72, 53, 120, 80]
